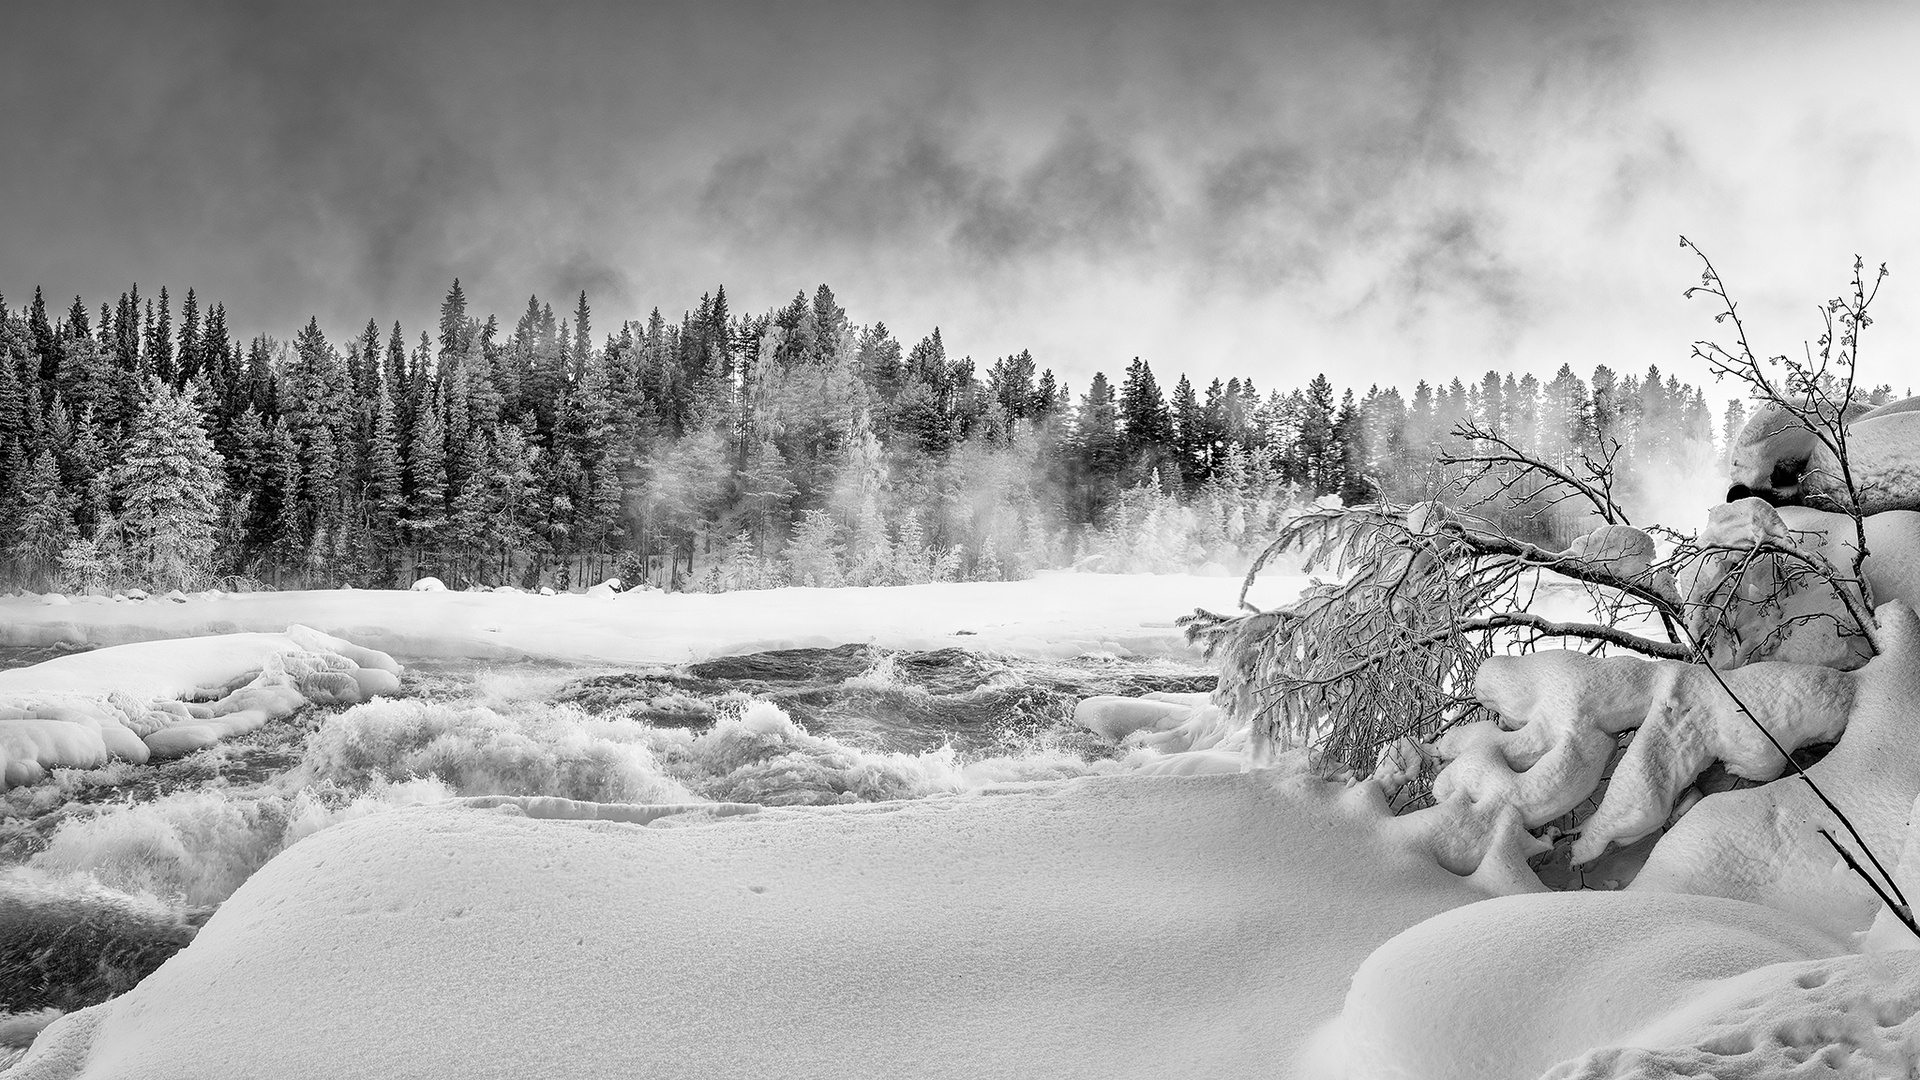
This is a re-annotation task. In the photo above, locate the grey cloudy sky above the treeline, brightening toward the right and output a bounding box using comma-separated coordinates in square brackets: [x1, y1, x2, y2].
[0, 0, 1920, 394]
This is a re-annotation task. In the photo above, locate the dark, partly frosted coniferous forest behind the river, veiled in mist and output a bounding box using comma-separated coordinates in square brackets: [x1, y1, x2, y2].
[0, 281, 1881, 592]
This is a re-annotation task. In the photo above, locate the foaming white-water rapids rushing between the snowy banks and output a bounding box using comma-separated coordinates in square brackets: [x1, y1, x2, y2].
[0, 646, 1213, 1013]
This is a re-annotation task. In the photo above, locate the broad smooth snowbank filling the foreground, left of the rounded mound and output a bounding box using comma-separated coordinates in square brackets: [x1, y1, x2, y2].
[10, 771, 1484, 1080]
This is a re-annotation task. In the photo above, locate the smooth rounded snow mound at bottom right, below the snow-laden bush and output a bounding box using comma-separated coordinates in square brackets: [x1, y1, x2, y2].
[1302, 892, 1843, 1080]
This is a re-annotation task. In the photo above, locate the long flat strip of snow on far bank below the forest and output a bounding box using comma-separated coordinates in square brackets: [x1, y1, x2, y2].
[0, 573, 1302, 663]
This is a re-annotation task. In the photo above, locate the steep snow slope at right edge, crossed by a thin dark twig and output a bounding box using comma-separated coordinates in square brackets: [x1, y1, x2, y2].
[1630, 601, 1920, 934]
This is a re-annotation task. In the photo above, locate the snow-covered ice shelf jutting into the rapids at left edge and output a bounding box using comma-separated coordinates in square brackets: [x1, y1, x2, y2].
[0, 626, 399, 790]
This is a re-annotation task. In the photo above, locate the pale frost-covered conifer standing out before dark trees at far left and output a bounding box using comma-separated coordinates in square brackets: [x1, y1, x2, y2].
[113, 380, 225, 588]
